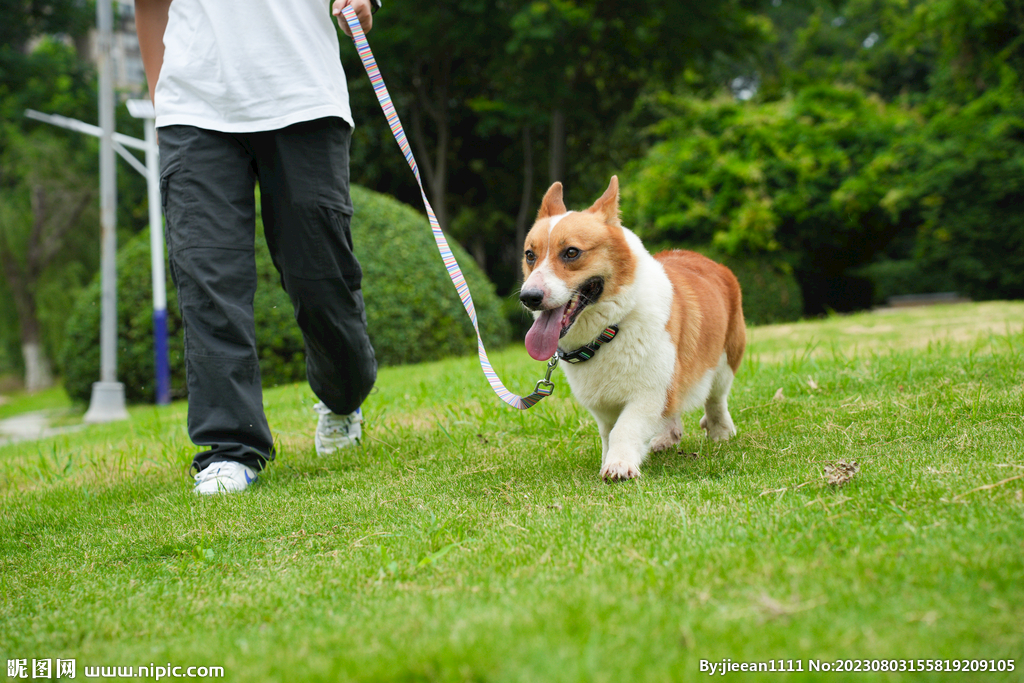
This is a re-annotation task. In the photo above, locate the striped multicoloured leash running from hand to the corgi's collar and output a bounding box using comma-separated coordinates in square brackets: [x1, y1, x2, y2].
[341, 6, 558, 411]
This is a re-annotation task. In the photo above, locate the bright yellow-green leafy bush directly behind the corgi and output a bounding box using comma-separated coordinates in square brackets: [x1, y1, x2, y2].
[623, 86, 920, 312]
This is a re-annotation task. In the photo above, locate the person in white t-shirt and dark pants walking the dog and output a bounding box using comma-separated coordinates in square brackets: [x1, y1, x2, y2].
[135, 0, 380, 494]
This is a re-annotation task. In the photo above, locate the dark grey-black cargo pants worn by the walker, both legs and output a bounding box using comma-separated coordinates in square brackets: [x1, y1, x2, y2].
[160, 118, 377, 470]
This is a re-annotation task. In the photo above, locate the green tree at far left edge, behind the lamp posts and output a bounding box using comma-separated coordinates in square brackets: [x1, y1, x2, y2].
[0, 15, 147, 385]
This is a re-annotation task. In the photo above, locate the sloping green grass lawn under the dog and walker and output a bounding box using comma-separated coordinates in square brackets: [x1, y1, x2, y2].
[0, 303, 1024, 681]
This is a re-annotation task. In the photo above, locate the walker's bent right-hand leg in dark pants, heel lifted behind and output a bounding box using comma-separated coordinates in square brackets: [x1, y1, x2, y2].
[253, 118, 377, 415]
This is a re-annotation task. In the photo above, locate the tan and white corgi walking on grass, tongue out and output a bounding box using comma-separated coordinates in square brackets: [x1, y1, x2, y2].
[519, 176, 746, 480]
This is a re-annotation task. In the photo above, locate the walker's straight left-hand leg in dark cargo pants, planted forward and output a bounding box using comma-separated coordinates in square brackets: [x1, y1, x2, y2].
[160, 126, 273, 470]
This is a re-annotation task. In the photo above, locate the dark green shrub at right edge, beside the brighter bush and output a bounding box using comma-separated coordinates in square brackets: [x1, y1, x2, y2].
[858, 75, 1024, 302]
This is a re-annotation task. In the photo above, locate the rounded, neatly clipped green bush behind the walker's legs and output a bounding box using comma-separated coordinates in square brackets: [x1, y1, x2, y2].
[62, 187, 509, 402]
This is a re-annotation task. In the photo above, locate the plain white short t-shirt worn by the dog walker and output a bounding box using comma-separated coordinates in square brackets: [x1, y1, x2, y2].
[155, 0, 353, 133]
